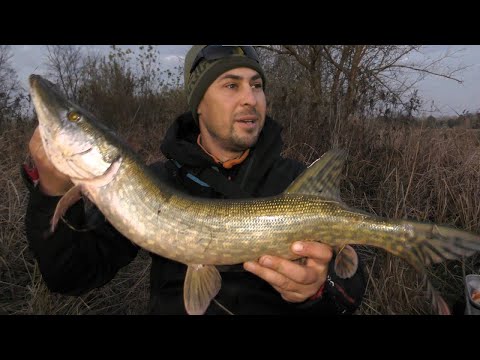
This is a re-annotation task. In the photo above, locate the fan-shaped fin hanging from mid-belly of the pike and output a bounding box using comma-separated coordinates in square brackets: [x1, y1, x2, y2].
[183, 265, 222, 315]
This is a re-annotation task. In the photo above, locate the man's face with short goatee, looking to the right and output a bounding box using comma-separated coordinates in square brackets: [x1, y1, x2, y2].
[198, 67, 267, 151]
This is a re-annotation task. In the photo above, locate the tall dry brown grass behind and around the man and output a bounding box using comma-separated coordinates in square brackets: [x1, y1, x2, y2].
[0, 118, 480, 315]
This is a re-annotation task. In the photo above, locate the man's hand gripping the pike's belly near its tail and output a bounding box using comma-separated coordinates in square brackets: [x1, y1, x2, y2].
[244, 241, 332, 302]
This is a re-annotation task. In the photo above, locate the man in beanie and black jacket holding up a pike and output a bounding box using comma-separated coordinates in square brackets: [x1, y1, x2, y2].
[22, 45, 365, 314]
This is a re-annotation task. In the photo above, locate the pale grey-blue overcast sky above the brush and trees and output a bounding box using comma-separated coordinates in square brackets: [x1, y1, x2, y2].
[8, 45, 480, 115]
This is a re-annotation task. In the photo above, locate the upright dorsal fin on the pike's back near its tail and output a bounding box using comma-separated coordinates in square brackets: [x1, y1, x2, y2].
[285, 149, 347, 202]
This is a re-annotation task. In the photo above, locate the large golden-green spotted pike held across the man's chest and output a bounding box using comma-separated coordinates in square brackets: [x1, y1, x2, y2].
[29, 75, 480, 314]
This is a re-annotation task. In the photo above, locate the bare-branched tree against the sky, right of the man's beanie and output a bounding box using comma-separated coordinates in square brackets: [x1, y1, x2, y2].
[262, 45, 462, 127]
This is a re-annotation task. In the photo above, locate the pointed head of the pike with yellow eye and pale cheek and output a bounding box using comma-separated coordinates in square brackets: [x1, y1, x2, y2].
[29, 74, 120, 182]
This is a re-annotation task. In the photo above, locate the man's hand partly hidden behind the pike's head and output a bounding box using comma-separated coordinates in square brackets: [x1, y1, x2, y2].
[28, 126, 73, 196]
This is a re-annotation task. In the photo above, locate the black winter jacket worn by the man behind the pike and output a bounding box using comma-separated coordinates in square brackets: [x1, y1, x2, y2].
[26, 113, 365, 315]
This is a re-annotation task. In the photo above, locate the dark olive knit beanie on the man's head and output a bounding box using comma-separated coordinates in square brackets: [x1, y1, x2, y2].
[184, 45, 265, 125]
